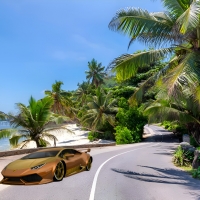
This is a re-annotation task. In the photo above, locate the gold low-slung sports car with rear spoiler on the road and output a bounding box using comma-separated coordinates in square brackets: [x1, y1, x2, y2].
[1, 148, 93, 185]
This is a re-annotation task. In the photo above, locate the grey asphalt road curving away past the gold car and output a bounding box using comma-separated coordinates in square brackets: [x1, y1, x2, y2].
[0, 126, 200, 200]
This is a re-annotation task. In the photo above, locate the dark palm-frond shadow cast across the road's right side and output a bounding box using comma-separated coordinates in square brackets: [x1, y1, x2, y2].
[111, 165, 200, 198]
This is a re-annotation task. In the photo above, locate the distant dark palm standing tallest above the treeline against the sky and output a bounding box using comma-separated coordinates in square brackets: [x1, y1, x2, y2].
[85, 59, 106, 88]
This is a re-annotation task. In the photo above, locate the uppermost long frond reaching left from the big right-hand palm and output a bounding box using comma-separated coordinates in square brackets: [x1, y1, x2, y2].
[109, 8, 173, 46]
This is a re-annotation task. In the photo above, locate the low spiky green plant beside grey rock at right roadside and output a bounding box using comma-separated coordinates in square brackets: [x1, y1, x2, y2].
[173, 146, 194, 167]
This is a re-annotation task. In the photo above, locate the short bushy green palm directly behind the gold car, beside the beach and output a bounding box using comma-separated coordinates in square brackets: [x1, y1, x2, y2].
[0, 97, 68, 148]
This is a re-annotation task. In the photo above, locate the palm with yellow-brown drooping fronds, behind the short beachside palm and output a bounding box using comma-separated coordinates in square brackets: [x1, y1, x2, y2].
[45, 81, 74, 117]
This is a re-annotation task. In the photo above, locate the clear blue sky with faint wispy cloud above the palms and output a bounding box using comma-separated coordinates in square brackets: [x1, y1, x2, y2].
[0, 0, 164, 113]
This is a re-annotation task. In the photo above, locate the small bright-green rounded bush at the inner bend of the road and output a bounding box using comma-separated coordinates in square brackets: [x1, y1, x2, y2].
[115, 126, 133, 144]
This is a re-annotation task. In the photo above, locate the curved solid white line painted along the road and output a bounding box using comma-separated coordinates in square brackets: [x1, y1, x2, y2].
[89, 143, 160, 200]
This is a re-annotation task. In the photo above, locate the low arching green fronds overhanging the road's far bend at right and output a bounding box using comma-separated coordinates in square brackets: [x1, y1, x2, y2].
[145, 90, 200, 144]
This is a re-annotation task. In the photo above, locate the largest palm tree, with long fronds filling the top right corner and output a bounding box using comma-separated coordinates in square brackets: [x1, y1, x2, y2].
[109, 0, 200, 103]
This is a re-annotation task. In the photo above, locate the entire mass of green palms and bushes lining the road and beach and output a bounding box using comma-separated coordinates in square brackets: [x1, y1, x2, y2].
[0, 0, 200, 177]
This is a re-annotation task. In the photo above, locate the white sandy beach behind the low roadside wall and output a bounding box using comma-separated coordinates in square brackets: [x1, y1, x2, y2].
[18, 124, 114, 148]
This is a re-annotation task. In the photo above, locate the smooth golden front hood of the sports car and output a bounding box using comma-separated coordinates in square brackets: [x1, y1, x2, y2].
[6, 157, 58, 170]
